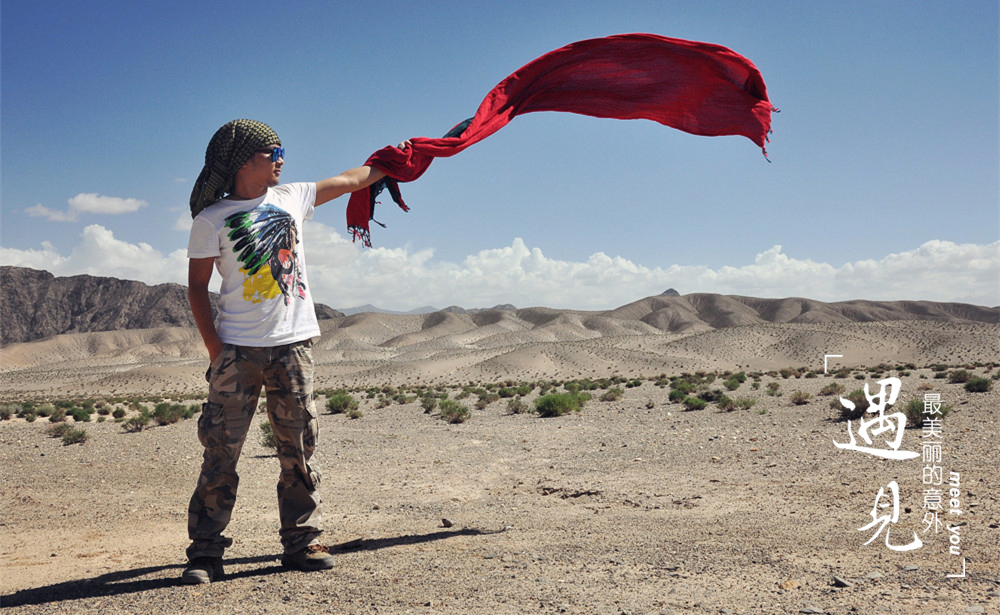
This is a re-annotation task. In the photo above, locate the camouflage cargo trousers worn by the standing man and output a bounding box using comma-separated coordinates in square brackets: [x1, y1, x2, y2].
[187, 341, 322, 559]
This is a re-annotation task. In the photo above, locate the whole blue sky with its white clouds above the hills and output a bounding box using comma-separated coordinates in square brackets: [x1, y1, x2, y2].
[0, 0, 1000, 310]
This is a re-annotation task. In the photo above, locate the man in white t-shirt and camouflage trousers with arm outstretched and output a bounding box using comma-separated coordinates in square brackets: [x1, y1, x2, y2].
[181, 119, 408, 583]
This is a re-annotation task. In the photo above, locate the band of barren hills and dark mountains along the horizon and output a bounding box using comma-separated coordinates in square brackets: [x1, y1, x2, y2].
[0, 267, 1000, 395]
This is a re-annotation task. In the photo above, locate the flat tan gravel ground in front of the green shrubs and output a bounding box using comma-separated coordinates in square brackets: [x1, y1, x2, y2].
[0, 370, 1000, 615]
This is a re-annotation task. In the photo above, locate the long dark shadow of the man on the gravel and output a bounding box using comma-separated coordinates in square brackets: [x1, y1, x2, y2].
[0, 528, 504, 608]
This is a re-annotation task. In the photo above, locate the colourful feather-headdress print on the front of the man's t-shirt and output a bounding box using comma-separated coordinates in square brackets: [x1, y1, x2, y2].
[225, 203, 306, 305]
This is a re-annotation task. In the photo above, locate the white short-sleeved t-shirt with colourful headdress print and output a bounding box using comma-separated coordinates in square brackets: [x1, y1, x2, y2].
[188, 183, 320, 347]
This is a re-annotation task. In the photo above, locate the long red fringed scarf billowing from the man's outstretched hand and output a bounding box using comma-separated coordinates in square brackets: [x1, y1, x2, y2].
[347, 34, 776, 246]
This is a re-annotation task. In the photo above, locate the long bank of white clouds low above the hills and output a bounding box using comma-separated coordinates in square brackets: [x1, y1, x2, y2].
[0, 221, 1000, 310]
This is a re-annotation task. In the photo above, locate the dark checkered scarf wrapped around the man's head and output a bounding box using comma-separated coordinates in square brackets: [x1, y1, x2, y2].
[190, 120, 281, 218]
